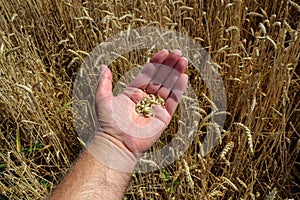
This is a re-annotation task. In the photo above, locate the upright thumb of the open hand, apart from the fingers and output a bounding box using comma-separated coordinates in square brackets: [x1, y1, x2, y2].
[96, 64, 112, 98]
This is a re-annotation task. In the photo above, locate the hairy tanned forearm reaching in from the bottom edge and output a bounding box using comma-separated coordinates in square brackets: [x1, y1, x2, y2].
[49, 135, 135, 200]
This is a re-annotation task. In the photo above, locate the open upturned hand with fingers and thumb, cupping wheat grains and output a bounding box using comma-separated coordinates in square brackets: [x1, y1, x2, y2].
[89, 50, 188, 170]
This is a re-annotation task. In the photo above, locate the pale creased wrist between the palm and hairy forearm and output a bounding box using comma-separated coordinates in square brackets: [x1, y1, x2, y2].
[87, 132, 137, 173]
